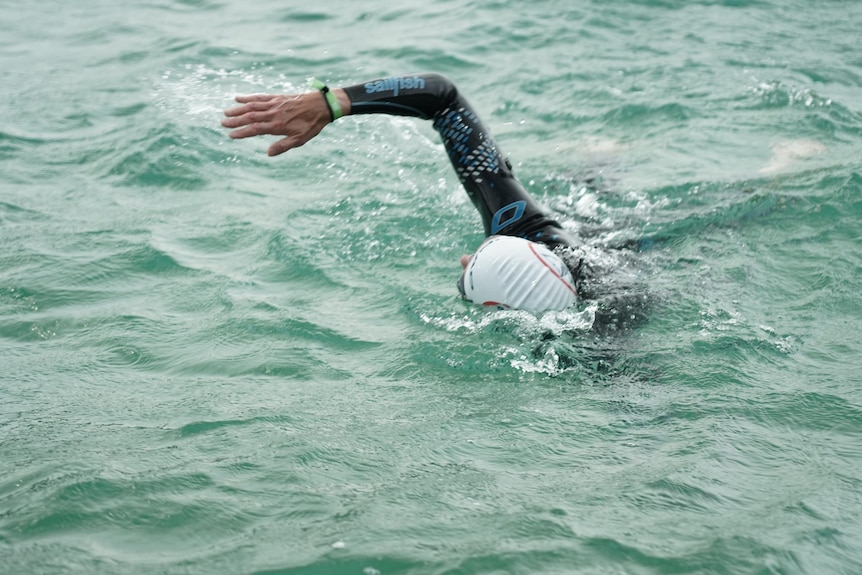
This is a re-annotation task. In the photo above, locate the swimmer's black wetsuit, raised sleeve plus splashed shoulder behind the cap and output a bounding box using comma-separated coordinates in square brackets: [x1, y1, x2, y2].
[345, 74, 650, 333]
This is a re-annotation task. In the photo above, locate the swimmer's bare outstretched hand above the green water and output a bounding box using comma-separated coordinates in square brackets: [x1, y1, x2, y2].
[221, 91, 330, 156]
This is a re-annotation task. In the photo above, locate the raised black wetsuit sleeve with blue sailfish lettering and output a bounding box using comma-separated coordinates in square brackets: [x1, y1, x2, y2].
[344, 74, 575, 248]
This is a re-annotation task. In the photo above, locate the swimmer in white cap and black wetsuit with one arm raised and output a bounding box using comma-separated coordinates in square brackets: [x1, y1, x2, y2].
[222, 74, 580, 313]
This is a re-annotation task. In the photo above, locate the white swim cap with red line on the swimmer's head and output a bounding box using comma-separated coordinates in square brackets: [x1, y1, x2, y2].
[458, 236, 577, 313]
